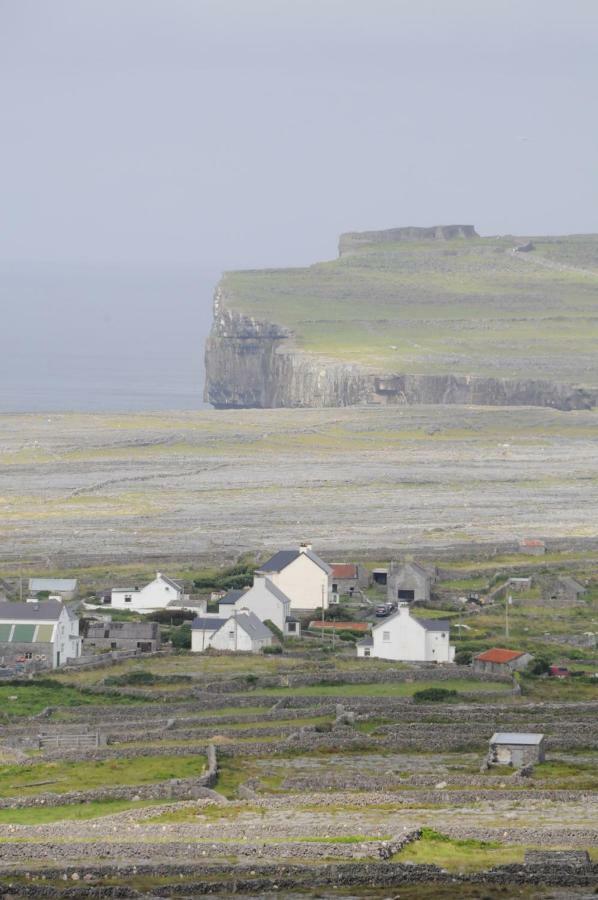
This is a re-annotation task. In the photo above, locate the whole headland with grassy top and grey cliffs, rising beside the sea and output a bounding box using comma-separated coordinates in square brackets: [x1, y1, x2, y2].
[205, 225, 598, 410]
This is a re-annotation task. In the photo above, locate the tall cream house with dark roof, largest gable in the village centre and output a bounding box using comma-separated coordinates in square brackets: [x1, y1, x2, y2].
[256, 544, 332, 612]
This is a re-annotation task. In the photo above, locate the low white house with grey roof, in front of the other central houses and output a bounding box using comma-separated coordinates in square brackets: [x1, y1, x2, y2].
[191, 609, 272, 653]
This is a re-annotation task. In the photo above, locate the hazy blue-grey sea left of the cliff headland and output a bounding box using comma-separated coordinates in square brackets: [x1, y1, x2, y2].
[0, 262, 220, 413]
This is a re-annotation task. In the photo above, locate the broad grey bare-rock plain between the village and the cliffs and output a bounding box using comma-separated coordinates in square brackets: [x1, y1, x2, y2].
[0, 406, 598, 568]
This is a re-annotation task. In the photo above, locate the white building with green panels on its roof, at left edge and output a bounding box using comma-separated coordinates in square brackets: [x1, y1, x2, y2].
[0, 600, 81, 670]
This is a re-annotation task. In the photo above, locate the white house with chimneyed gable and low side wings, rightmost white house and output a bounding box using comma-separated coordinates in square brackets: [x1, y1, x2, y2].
[357, 603, 455, 663]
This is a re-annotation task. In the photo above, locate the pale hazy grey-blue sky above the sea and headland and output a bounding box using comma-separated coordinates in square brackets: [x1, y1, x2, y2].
[0, 0, 598, 409]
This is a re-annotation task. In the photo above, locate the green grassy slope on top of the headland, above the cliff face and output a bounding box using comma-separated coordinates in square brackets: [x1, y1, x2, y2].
[221, 235, 598, 388]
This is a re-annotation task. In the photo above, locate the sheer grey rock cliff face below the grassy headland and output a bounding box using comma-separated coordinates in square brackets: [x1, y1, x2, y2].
[204, 288, 597, 410]
